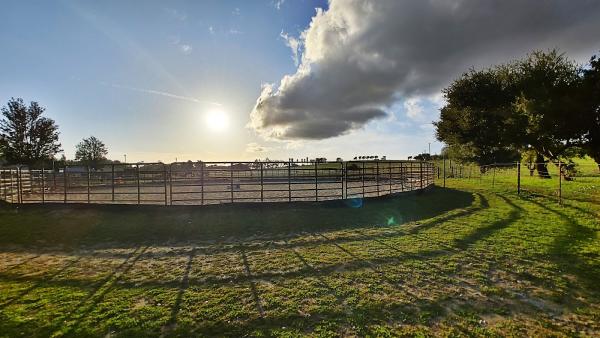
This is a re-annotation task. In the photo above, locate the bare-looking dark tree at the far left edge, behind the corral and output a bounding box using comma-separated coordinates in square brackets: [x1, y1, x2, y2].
[0, 98, 60, 165]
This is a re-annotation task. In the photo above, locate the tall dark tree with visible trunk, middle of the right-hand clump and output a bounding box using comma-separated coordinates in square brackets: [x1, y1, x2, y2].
[513, 50, 585, 177]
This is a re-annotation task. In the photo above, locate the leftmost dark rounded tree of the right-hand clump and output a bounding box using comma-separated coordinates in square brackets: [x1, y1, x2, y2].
[435, 67, 518, 164]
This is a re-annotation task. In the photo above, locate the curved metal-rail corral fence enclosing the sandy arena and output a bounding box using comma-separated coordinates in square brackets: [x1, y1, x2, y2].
[0, 161, 435, 205]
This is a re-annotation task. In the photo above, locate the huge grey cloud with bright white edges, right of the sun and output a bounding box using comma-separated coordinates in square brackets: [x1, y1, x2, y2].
[249, 0, 600, 140]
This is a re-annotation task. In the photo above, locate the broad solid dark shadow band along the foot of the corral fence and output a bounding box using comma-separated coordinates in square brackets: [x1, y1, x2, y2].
[0, 187, 474, 248]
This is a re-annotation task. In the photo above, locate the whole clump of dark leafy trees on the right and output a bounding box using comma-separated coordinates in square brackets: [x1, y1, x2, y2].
[435, 50, 600, 177]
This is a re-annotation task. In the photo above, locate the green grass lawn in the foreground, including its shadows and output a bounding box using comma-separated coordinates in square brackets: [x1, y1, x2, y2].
[0, 180, 600, 337]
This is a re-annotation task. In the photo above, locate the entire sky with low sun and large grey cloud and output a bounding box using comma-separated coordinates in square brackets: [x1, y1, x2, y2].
[0, 0, 600, 162]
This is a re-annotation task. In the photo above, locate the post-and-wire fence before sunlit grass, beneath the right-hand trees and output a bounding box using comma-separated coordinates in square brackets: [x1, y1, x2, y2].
[435, 160, 600, 203]
